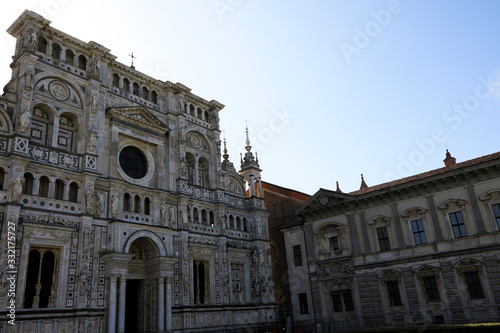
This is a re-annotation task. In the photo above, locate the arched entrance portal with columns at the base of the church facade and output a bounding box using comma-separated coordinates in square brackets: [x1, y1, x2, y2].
[103, 231, 176, 333]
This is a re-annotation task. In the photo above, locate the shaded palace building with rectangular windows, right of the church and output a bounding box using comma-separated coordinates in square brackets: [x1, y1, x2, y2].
[282, 152, 500, 332]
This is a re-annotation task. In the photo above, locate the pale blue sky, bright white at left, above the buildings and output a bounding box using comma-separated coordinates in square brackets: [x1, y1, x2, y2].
[0, 0, 500, 195]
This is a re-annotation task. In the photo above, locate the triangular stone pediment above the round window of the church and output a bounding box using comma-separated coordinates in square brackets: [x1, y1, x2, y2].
[106, 107, 170, 134]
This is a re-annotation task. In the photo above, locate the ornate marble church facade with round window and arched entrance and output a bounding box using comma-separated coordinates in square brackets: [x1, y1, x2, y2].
[0, 11, 276, 333]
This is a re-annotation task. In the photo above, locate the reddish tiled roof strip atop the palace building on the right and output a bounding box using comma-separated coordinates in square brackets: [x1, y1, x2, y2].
[349, 152, 500, 195]
